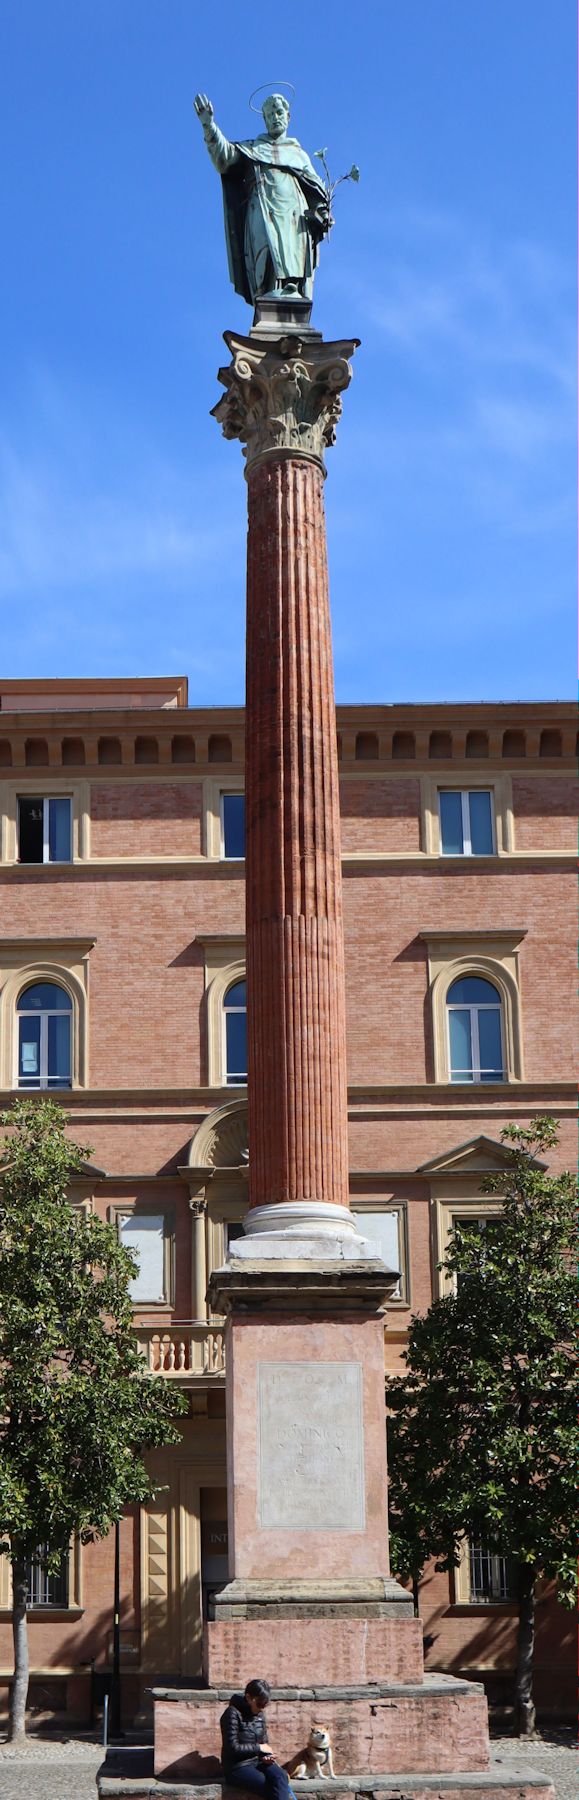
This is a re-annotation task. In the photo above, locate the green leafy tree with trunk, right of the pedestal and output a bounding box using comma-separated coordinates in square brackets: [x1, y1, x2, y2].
[388, 1118, 579, 1735]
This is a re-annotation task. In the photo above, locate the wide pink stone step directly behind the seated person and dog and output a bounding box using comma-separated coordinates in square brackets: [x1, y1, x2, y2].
[155, 1676, 489, 1791]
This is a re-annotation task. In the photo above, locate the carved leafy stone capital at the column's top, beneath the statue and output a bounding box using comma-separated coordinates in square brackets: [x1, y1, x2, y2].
[212, 331, 358, 468]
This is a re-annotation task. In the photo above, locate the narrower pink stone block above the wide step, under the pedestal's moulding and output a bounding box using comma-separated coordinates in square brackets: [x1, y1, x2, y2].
[203, 1616, 423, 1688]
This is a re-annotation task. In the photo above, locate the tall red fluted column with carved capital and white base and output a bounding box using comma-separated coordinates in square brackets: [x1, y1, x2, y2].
[214, 331, 361, 1224]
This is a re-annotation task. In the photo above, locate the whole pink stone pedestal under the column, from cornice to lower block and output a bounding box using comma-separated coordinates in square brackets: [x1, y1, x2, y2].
[205, 1260, 411, 1687]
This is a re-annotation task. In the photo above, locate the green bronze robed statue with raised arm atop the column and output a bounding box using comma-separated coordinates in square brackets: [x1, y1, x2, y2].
[194, 94, 331, 304]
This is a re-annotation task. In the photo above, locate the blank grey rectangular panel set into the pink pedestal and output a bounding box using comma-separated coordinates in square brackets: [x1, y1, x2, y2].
[257, 1363, 365, 1532]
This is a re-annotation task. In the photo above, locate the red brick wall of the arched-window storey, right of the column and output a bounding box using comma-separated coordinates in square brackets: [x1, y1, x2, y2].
[343, 864, 575, 1084]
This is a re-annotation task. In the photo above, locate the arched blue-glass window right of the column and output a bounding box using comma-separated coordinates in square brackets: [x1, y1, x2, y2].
[446, 976, 505, 1082]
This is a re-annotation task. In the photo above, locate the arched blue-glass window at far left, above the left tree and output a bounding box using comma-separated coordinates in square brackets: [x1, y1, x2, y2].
[16, 981, 72, 1087]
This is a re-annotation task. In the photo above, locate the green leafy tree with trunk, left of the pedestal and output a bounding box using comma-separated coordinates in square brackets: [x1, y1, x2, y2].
[0, 1100, 183, 1741]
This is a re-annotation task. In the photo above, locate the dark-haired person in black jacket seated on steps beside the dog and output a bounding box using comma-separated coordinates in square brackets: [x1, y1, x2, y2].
[219, 1681, 295, 1800]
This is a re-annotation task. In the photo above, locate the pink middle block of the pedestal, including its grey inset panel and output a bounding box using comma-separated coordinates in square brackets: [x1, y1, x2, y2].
[217, 1294, 388, 1591]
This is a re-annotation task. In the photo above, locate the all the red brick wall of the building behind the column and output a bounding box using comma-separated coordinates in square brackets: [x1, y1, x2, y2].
[0, 745, 577, 1701]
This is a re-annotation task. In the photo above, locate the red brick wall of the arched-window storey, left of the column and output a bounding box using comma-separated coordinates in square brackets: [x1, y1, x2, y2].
[2, 864, 245, 1087]
